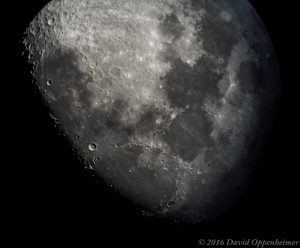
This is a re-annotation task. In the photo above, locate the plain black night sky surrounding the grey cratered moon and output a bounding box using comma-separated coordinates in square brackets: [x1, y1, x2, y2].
[2, 0, 300, 247]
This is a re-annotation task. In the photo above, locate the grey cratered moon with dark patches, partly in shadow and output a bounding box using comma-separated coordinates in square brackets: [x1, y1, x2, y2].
[24, 0, 279, 223]
